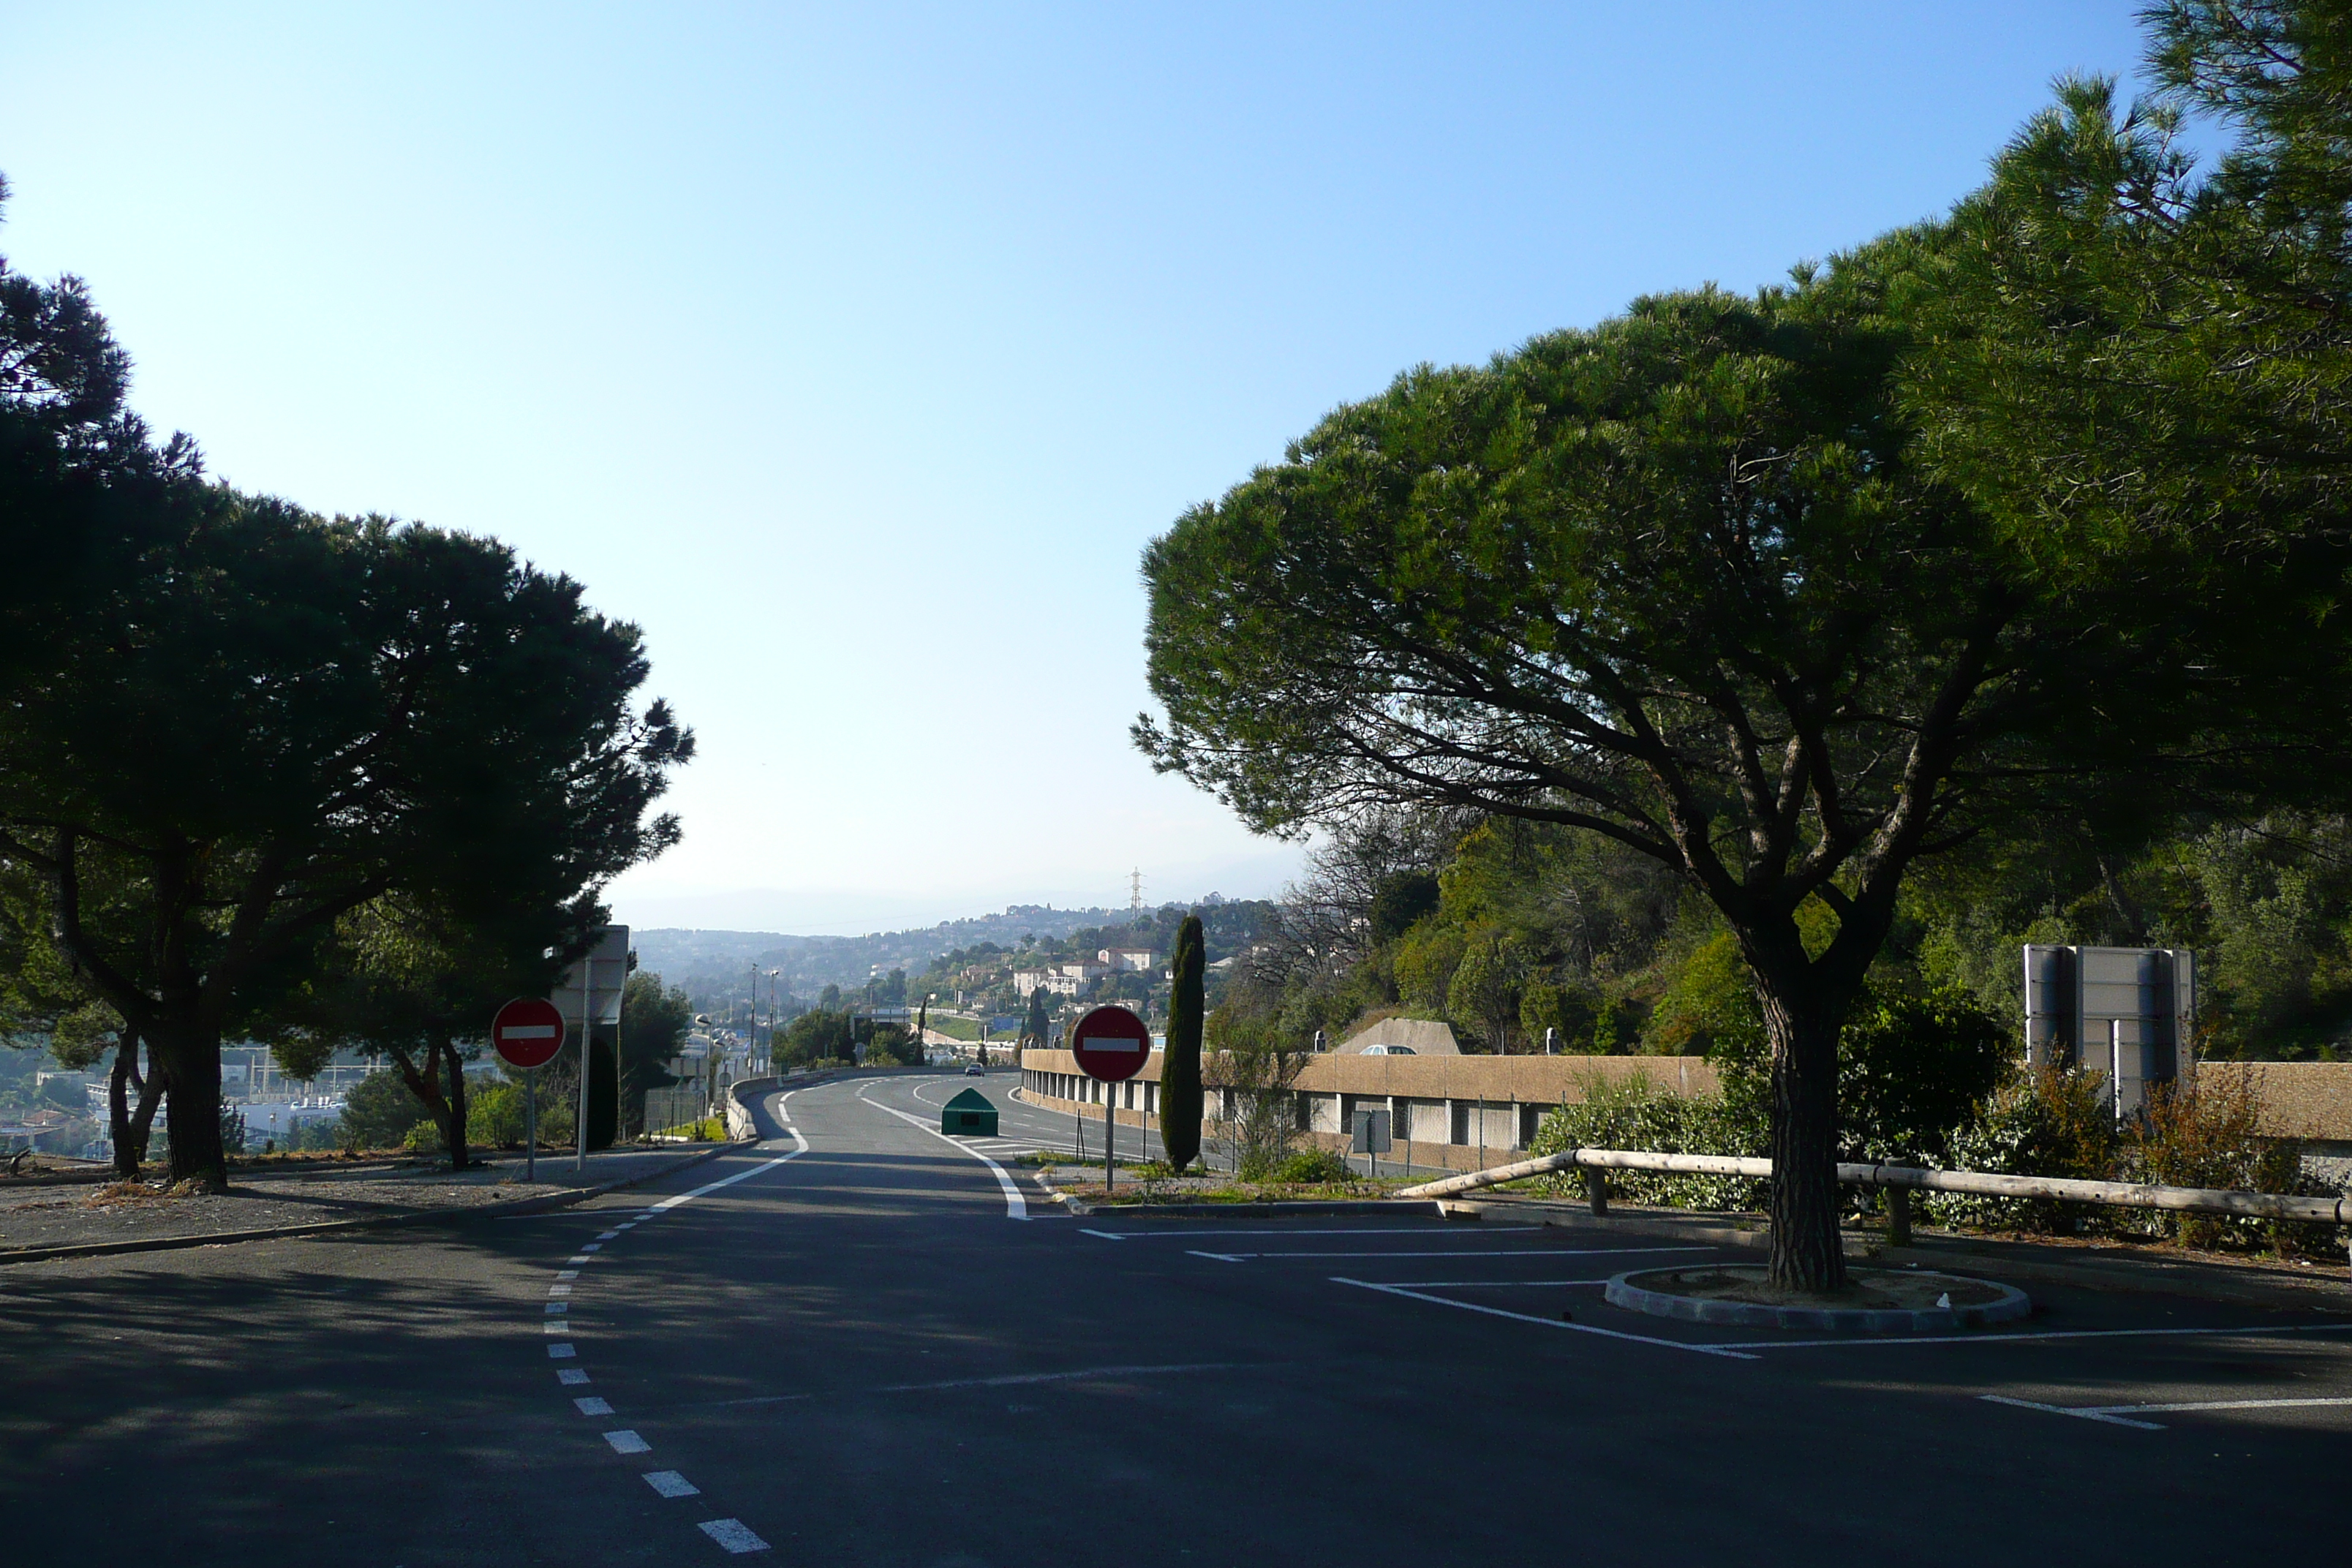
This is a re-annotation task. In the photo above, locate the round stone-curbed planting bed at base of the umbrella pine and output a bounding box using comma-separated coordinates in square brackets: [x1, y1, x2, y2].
[1607, 1262, 2035, 1333]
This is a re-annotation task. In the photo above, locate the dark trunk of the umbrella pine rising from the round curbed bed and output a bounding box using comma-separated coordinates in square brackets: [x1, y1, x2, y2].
[1757, 987, 1847, 1295]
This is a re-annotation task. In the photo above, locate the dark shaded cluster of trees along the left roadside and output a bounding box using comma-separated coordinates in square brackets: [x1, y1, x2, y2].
[0, 186, 694, 1189]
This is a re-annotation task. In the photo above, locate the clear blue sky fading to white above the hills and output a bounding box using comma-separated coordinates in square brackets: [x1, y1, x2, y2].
[0, 0, 2138, 931]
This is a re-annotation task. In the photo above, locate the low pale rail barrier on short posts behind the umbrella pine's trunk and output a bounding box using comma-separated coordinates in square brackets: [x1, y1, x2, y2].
[1397, 1150, 2352, 1229]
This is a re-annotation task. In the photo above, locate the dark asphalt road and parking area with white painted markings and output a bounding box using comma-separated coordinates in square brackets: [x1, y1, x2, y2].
[0, 1072, 2352, 1568]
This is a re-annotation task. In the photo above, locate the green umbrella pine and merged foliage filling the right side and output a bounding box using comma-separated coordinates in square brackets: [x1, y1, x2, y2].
[1134, 0, 2352, 1291]
